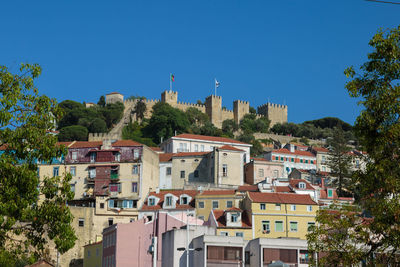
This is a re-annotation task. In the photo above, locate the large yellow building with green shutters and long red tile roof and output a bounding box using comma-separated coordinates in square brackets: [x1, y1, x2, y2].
[243, 192, 318, 239]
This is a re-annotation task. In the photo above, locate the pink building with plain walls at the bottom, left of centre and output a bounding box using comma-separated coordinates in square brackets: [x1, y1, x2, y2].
[103, 214, 203, 267]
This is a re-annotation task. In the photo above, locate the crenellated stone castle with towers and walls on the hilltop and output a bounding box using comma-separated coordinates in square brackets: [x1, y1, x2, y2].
[89, 90, 288, 141]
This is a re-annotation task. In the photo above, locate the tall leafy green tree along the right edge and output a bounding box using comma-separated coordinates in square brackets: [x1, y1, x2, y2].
[309, 26, 400, 266]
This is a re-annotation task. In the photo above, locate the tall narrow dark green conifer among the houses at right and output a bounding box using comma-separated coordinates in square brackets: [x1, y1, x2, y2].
[328, 127, 352, 196]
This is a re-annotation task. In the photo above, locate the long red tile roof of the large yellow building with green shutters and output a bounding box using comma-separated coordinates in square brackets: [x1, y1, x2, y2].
[248, 192, 317, 205]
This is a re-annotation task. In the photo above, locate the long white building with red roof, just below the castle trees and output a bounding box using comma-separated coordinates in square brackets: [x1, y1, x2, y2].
[161, 134, 252, 163]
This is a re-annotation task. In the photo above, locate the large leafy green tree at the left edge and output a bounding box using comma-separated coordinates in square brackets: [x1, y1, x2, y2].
[0, 64, 76, 266]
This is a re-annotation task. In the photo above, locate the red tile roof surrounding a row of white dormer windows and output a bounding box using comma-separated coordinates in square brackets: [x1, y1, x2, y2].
[141, 190, 198, 210]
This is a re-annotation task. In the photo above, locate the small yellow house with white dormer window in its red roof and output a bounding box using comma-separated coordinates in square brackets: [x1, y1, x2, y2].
[208, 207, 252, 240]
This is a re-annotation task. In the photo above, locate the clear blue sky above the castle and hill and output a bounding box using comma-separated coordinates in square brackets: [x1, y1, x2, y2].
[0, 0, 400, 124]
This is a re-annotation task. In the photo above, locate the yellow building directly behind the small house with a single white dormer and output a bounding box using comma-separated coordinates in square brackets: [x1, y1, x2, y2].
[196, 190, 243, 221]
